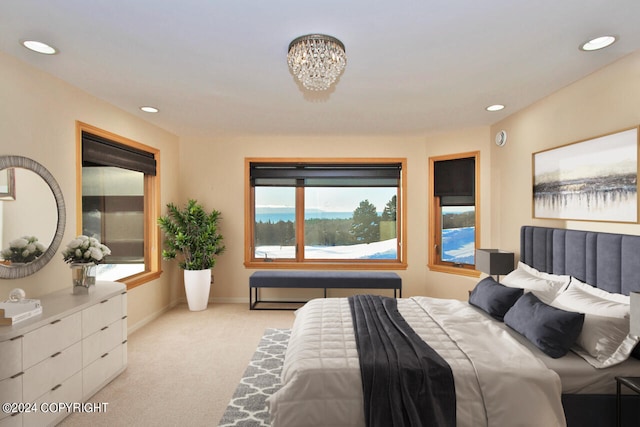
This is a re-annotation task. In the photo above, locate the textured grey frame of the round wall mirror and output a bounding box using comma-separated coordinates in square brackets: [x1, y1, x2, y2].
[0, 156, 67, 279]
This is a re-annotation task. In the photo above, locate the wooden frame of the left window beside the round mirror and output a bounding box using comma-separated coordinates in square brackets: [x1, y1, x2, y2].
[76, 121, 162, 290]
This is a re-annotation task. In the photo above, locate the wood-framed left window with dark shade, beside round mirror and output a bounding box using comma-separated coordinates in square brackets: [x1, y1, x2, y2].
[77, 123, 160, 288]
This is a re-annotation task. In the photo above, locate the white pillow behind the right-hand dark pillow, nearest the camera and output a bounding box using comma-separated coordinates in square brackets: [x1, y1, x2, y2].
[551, 278, 639, 368]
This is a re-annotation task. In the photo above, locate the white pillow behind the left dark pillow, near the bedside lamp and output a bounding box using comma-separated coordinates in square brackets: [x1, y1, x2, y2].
[500, 262, 571, 304]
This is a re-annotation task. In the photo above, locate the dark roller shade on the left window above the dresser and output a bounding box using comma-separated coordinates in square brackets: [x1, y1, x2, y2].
[82, 132, 156, 175]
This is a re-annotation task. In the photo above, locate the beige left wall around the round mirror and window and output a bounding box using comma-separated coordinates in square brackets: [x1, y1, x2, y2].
[0, 54, 181, 327]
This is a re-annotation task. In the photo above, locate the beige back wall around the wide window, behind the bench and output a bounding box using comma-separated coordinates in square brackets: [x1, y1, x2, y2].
[180, 128, 491, 302]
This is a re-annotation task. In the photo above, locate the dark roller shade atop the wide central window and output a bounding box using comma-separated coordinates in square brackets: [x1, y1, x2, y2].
[250, 163, 402, 187]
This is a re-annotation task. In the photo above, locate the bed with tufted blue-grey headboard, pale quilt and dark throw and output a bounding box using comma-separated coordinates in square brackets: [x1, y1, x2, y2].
[269, 226, 640, 427]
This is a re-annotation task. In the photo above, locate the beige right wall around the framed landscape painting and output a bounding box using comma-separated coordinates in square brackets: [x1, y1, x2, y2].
[491, 52, 640, 252]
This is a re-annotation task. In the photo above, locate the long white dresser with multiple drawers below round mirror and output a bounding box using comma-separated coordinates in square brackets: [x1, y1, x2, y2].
[0, 281, 127, 427]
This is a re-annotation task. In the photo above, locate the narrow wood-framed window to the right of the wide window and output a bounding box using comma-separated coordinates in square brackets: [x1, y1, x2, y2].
[429, 152, 480, 275]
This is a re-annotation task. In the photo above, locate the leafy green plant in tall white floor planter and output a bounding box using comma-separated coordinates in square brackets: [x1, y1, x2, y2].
[158, 200, 225, 311]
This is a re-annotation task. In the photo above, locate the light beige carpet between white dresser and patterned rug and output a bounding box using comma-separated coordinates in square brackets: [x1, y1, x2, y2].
[60, 304, 294, 427]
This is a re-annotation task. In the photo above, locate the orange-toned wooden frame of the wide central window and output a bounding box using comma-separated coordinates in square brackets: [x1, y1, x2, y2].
[244, 157, 407, 270]
